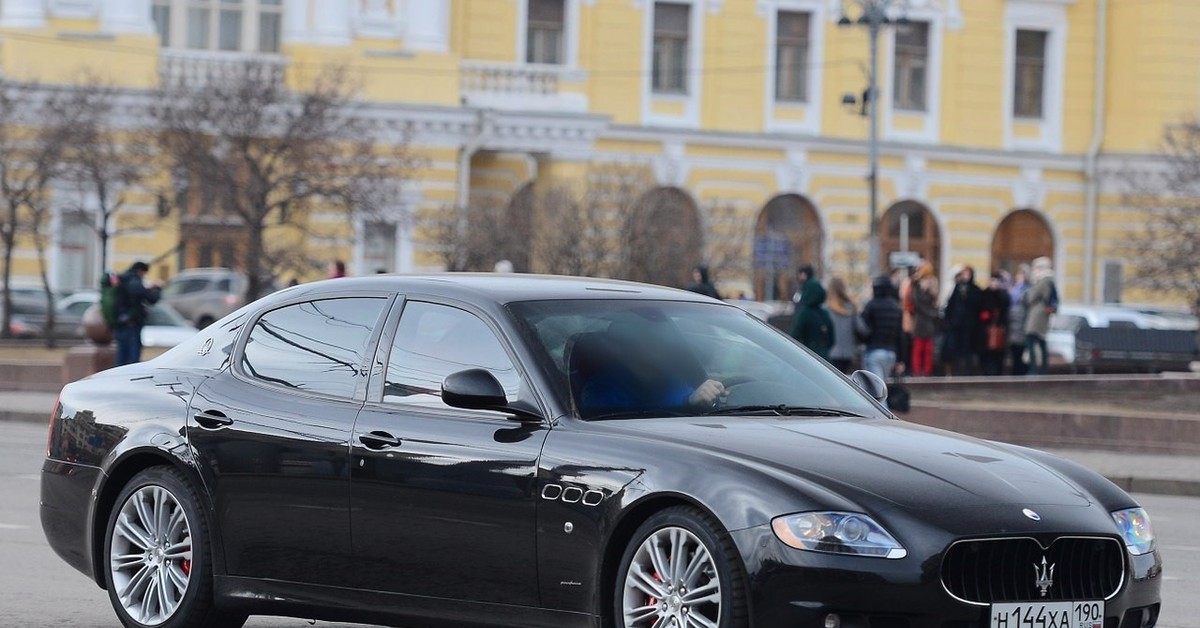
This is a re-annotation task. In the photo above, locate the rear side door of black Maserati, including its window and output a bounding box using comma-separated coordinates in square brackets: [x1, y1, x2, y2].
[187, 294, 390, 585]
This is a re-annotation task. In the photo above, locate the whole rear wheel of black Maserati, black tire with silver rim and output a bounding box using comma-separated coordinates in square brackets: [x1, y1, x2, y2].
[103, 467, 246, 628]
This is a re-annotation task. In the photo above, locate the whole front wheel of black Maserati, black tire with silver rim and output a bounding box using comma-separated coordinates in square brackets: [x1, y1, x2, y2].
[612, 507, 748, 628]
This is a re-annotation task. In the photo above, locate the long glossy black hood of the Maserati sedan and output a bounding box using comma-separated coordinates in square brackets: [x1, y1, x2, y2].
[609, 417, 1092, 510]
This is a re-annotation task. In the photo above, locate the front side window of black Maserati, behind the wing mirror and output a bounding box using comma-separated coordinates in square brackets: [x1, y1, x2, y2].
[383, 301, 521, 408]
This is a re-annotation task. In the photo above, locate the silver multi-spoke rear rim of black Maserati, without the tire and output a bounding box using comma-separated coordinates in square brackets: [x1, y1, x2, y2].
[108, 485, 192, 626]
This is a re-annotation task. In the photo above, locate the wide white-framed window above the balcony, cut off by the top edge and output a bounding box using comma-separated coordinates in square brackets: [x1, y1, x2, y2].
[151, 0, 283, 53]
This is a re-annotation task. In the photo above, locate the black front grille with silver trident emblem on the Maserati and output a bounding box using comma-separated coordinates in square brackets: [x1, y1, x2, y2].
[942, 537, 1124, 604]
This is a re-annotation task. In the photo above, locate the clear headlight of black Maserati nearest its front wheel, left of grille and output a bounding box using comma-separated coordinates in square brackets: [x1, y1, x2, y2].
[770, 513, 908, 558]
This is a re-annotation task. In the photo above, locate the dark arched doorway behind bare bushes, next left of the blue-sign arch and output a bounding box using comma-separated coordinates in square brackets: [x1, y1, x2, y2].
[624, 187, 704, 287]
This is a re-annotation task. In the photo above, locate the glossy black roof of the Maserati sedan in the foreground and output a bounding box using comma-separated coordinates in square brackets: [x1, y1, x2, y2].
[278, 273, 715, 304]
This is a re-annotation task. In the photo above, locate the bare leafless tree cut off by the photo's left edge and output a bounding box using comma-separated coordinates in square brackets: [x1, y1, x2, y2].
[0, 79, 82, 346]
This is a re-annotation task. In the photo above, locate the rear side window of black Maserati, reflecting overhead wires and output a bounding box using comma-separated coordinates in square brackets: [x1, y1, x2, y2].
[241, 297, 388, 399]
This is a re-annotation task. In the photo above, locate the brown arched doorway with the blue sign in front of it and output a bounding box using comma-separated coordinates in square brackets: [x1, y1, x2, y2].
[754, 195, 824, 301]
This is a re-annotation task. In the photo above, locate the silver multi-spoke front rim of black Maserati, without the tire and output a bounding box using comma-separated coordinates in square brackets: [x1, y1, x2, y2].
[622, 527, 721, 628]
